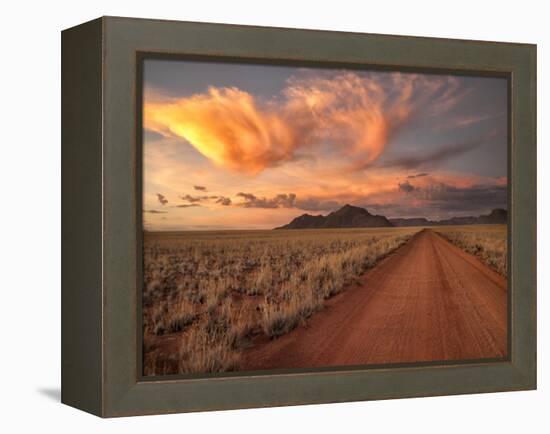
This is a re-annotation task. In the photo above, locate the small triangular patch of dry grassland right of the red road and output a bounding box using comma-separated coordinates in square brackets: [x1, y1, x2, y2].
[433, 224, 508, 276]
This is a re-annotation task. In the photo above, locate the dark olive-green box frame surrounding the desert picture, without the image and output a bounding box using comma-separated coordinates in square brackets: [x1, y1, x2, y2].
[62, 17, 536, 417]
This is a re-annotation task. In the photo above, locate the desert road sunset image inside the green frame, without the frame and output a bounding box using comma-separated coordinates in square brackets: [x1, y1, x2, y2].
[140, 58, 509, 376]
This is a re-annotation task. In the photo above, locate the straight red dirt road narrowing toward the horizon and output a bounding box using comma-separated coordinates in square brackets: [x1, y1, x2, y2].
[240, 230, 507, 370]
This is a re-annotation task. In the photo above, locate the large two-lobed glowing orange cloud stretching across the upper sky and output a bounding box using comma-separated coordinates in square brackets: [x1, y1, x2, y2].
[144, 72, 468, 175]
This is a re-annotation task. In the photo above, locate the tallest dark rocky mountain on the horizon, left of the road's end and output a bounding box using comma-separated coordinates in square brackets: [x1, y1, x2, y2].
[277, 205, 393, 229]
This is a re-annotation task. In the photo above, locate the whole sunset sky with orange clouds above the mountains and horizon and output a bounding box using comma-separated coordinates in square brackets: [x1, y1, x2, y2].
[143, 59, 508, 231]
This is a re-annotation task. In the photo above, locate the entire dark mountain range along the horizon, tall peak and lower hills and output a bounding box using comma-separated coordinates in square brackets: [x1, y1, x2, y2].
[276, 205, 508, 229]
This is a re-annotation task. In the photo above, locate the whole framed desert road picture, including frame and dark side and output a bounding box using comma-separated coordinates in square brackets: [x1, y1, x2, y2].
[62, 17, 536, 417]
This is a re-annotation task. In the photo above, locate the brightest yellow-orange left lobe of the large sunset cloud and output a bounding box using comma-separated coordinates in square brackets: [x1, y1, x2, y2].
[144, 87, 295, 174]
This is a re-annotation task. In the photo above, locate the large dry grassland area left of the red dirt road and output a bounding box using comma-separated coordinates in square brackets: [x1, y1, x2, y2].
[143, 228, 420, 375]
